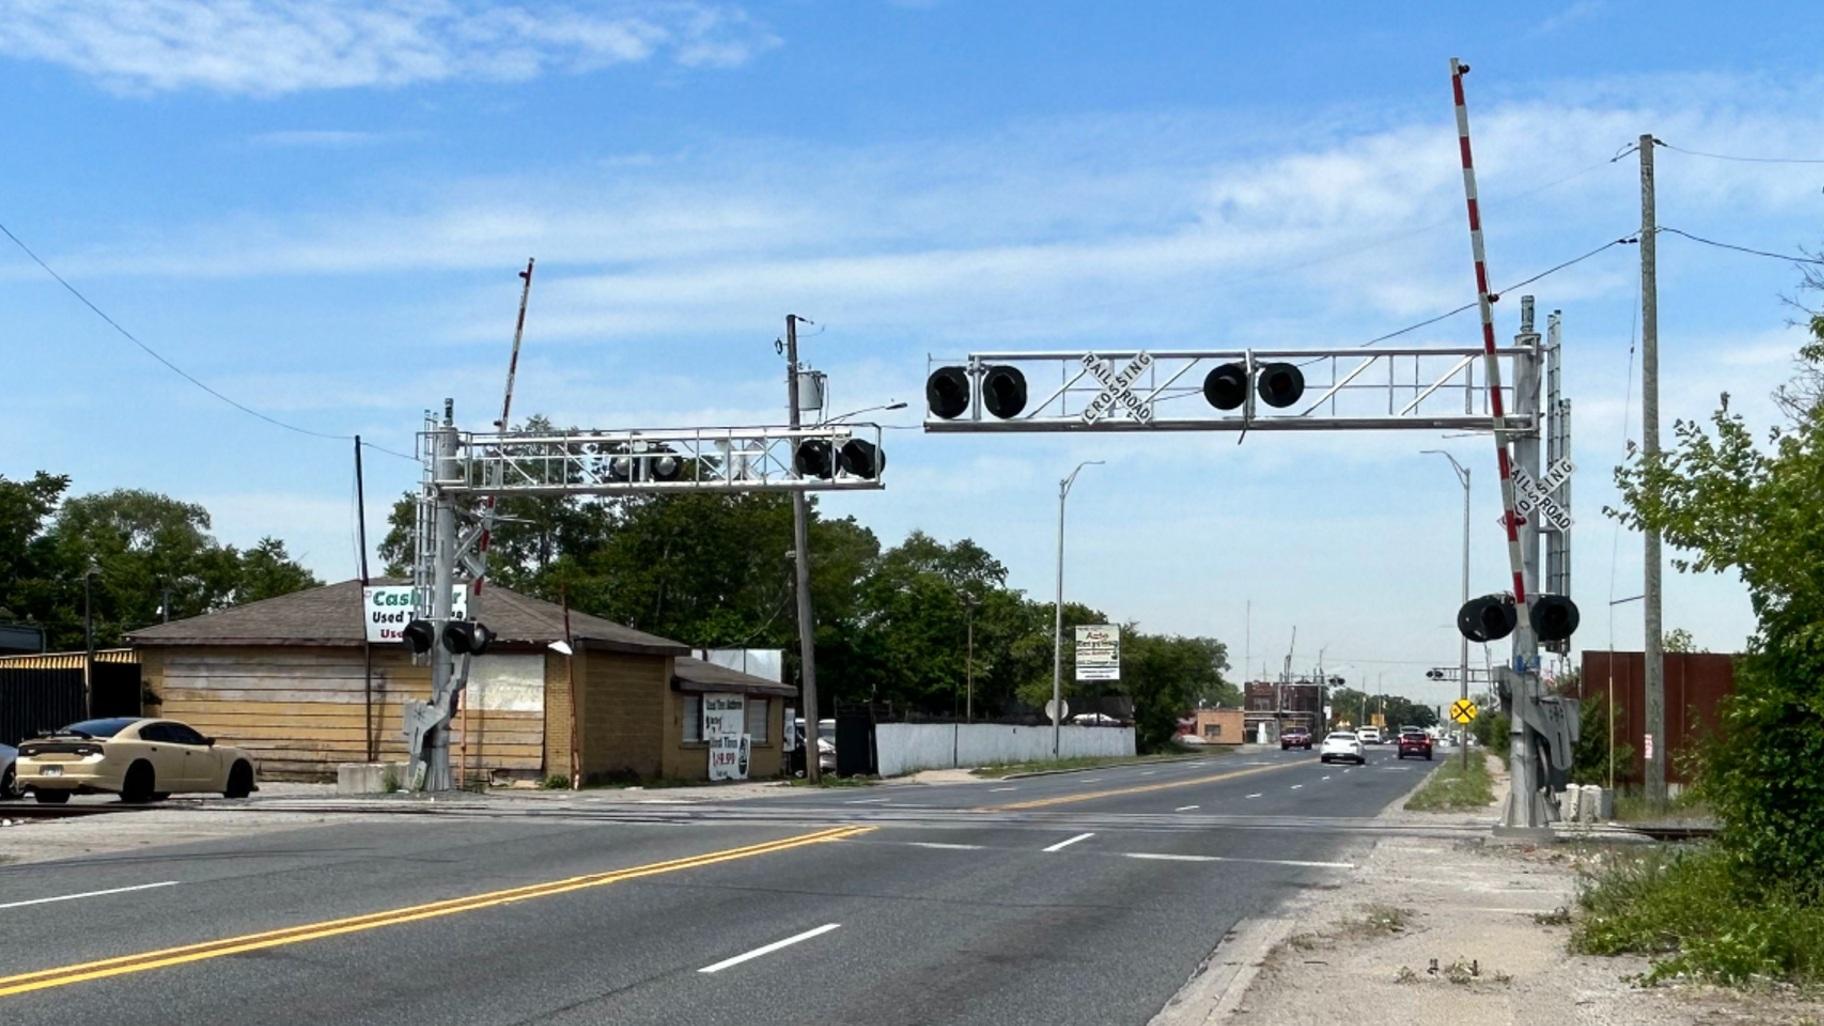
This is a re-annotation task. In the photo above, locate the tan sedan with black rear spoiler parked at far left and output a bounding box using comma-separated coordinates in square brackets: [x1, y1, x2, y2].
[16, 716, 259, 805]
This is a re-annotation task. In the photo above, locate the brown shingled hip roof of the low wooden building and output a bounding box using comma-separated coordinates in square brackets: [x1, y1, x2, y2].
[128, 579, 689, 655]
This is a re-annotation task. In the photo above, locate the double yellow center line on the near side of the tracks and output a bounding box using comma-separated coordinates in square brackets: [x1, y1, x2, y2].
[0, 827, 874, 997]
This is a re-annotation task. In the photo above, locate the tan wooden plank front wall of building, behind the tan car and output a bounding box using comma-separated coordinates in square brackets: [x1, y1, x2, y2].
[144, 646, 549, 778]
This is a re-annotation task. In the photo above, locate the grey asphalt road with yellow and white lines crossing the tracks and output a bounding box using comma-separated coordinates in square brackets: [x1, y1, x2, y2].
[0, 750, 1435, 1026]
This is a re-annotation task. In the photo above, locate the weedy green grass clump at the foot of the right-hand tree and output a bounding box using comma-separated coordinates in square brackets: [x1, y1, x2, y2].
[1570, 845, 1824, 986]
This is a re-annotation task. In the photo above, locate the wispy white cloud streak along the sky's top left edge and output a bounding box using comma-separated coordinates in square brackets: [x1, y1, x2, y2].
[0, 0, 779, 95]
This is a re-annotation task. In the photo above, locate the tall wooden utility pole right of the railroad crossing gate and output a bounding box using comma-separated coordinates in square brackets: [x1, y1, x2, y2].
[1640, 133, 1665, 803]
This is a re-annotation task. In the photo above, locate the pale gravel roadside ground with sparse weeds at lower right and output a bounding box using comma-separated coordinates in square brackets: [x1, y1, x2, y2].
[1209, 748, 1824, 1026]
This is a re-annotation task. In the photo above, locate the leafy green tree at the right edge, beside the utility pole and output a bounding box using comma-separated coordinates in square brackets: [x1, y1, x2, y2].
[1609, 318, 1824, 893]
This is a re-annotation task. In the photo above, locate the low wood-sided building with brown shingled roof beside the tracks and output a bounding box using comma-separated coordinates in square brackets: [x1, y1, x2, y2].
[128, 581, 797, 785]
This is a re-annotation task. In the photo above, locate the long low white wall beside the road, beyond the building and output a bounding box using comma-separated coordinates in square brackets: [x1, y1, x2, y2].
[874, 723, 1135, 776]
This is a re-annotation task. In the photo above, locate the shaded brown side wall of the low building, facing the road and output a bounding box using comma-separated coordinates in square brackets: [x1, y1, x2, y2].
[576, 652, 671, 778]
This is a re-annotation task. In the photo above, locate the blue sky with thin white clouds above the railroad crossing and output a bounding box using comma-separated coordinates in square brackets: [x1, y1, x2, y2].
[0, 0, 1824, 697]
